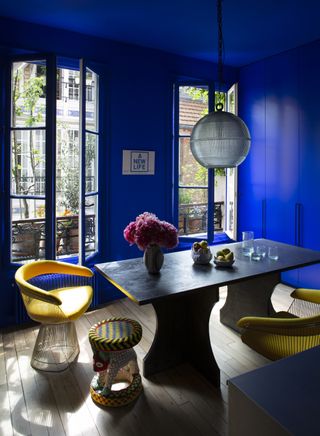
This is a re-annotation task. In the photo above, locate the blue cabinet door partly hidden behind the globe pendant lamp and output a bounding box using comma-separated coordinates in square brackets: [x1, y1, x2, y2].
[238, 63, 265, 240]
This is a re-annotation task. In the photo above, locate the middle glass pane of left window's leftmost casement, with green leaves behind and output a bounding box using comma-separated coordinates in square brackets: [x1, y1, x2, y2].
[11, 130, 46, 195]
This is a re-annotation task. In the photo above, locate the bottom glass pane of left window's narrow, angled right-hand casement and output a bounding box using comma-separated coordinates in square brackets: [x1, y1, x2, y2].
[85, 195, 98, 257]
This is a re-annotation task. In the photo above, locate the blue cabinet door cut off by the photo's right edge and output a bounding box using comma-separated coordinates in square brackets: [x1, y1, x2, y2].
[299, 41, 320, 288]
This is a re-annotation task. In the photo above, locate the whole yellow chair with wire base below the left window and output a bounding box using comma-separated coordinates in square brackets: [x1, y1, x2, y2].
[15, 260, 93, 371]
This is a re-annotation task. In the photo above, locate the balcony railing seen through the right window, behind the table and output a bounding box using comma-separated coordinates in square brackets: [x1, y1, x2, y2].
[179, 201, 224, 235]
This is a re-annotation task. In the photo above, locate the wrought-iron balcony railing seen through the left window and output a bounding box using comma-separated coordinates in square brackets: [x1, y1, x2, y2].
[11, 215, 96, 262]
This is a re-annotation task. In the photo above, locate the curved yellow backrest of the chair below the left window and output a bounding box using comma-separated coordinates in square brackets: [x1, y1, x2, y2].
[15, 260, 93, 305]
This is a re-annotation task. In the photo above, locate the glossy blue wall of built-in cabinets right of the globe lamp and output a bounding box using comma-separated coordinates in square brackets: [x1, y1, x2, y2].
[238, 41, 320, 288]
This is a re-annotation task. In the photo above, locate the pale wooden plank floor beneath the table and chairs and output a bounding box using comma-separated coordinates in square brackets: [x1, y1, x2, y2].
[0, 285, 291, 436]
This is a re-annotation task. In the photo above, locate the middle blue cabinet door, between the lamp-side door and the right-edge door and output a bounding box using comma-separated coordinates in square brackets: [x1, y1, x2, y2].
[265, 51, 299, 285]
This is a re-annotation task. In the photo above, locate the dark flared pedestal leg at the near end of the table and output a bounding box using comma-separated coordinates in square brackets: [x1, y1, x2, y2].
[143, 287, 220, 387]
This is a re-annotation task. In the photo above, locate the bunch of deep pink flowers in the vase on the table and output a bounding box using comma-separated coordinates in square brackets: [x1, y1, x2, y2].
[123, 212, 178, 251]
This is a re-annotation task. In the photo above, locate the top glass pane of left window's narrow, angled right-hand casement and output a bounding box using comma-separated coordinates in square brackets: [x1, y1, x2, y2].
[86, 68, 99, 132]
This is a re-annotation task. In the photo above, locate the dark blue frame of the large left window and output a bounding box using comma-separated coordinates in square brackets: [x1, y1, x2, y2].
[1, 53, 102, 267]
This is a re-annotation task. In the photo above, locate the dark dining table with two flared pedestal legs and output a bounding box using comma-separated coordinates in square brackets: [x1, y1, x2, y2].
[95, 239, 320, 387]
